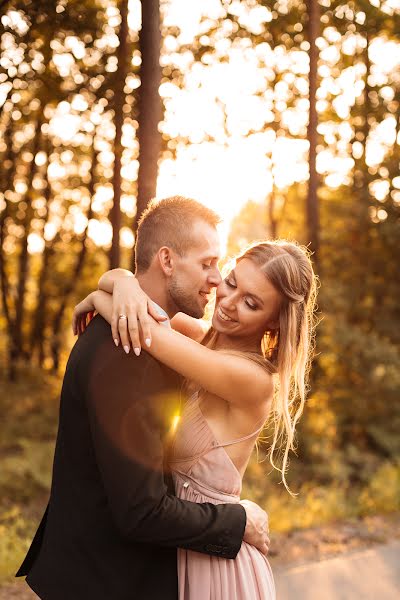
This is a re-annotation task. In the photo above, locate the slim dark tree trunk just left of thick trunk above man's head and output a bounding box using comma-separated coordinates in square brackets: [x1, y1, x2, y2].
[109, 0, 128, 269]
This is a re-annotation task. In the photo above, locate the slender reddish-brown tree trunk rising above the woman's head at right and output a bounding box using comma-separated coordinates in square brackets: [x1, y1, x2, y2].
[306, 0, 320, 264]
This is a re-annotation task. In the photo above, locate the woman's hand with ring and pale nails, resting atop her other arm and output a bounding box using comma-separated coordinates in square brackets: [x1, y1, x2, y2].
[111, 275, 167, 356]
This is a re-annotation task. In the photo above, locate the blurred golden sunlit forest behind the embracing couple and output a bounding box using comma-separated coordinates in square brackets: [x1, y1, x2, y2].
[0, 0, 400, 580]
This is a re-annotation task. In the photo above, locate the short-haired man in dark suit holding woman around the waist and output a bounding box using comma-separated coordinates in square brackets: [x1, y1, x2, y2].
[17, 197, 267, 600]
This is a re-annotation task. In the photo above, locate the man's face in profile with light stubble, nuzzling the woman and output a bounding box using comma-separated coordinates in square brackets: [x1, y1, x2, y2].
[168, 221, 221, 319]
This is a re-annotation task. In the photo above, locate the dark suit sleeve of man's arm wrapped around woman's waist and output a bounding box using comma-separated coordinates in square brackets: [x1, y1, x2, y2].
[87, 342, 246, 558]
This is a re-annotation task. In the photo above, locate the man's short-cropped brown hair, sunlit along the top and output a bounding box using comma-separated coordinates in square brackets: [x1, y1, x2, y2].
[135, 196, 221, 273]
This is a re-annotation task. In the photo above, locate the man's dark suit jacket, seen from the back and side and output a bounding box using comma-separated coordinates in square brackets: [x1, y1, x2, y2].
[17, 315, 246, 600]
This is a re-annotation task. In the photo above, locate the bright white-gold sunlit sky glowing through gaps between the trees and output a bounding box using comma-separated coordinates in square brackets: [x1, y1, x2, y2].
[13, 0, 400, 252]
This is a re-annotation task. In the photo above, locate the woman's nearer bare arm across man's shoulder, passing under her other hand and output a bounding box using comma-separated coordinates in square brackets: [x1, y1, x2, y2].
[93, 291, 273, 408]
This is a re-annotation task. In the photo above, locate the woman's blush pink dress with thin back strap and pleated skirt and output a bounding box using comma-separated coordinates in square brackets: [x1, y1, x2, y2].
[170, 394, 275, 600]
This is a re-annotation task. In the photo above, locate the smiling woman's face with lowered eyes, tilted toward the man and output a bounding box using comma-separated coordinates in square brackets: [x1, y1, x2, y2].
[212, 258, 281, 344]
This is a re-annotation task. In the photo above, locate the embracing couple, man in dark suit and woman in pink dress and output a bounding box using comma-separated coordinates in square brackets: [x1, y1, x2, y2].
[17, 197, 316, 600]
